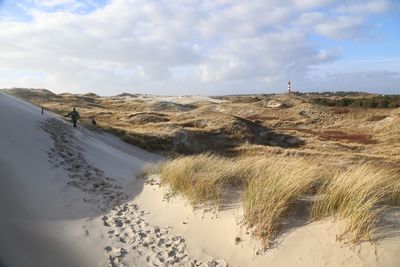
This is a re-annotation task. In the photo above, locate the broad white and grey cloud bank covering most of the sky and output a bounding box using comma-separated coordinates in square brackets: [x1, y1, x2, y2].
[0, 0, 398, 93]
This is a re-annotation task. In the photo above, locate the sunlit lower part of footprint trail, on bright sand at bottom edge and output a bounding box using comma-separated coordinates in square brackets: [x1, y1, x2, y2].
[102, 203, 228, 267]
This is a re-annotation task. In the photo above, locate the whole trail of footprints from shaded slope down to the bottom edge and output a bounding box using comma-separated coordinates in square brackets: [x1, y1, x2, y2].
[40, 118, 228, 267]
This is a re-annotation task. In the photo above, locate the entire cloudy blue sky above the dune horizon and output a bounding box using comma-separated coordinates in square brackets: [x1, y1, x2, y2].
[0, 0, 400, 95]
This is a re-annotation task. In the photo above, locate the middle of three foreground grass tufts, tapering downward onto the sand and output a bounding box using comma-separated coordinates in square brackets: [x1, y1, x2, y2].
[243, 156, 326, 247]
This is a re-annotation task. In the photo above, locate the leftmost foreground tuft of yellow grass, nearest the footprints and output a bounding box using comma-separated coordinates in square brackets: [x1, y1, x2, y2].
[144, 154, 250, 205]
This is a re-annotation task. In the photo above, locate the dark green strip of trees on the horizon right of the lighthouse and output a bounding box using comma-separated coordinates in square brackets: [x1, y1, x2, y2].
[313, 96, 400, 108]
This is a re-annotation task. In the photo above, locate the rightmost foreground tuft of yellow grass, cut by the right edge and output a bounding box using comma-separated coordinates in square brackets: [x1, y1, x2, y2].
[312, 163, 400, 243]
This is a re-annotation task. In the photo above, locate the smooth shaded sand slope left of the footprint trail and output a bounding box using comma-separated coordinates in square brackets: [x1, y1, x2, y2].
[0, 94, 99, 266]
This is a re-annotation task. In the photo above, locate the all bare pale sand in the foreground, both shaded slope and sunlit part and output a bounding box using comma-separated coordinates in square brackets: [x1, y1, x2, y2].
[0, 93, 400, 267]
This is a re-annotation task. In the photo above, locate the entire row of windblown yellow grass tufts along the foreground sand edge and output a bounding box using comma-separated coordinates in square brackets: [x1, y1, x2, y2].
[142, 154, 400, 247]
